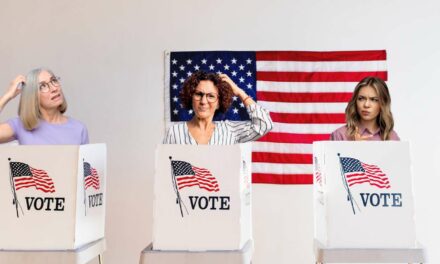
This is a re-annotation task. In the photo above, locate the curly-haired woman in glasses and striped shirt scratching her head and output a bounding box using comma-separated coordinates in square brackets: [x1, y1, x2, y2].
[163, 71, 273, 145]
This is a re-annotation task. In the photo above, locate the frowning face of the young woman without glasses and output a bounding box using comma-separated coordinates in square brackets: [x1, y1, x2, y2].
[356, 86, 380, 121]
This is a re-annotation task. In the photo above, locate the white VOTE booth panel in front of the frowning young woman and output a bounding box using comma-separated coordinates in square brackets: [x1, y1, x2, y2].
[313, 141, 416, 248]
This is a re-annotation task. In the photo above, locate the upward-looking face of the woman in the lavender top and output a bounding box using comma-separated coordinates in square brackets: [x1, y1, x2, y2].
[38, 71, 64, 110]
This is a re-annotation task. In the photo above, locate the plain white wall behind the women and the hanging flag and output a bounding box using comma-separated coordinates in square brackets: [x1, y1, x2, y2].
[0, 0, 440, 264]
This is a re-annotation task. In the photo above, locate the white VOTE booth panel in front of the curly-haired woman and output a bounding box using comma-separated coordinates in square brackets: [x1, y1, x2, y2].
[153, 144, 252, 251]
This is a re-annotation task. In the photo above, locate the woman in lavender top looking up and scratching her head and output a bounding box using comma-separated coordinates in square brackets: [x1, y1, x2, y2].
[0, 68, 89, 145]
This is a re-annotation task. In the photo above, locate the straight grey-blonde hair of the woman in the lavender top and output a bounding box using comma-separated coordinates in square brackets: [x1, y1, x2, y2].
[18, 68, 67, 131]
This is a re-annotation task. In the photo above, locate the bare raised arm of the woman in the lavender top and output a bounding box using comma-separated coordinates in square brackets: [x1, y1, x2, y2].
[0, 75, 26, 143]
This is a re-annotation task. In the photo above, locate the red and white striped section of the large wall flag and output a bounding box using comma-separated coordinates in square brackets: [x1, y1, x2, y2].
[252, 50, 387, 184]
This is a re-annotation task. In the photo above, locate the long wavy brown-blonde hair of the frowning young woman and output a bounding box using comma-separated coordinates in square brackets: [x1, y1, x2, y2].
[345, 77, 394, 140]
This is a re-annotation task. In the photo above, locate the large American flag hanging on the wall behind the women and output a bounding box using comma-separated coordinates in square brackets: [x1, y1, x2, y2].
[165, 50, 387, 184]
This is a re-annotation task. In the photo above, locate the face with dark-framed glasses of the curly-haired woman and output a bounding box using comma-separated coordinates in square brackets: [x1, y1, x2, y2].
[192, 80, 219, 119]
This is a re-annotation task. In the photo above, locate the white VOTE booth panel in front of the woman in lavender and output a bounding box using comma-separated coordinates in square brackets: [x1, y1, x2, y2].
[0, 144, 107, 250]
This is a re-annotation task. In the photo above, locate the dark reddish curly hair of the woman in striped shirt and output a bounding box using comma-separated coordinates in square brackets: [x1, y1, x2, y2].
[180, 71, 233, 113]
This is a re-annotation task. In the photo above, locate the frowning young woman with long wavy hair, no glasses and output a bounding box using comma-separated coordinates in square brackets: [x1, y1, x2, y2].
[330, 77, 400, 140]
